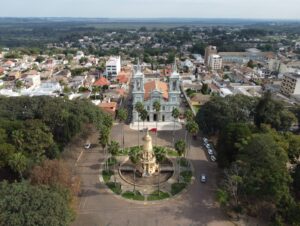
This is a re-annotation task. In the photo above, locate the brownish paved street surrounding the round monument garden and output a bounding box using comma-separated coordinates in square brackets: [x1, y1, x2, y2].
[73, 125, 233, 226]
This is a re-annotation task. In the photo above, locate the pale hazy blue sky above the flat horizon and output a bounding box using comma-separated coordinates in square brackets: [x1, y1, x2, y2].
[0, 0, 300, 20]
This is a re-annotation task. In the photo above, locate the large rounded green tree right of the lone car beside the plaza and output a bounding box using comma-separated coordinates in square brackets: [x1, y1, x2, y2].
[237, 134, 291, 205]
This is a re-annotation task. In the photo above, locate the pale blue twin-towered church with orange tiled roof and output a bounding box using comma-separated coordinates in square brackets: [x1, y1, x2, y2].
[132, 62, 180, 123]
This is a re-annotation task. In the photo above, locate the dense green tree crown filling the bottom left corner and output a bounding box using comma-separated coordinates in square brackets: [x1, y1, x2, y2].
[0, 181, 75, 226]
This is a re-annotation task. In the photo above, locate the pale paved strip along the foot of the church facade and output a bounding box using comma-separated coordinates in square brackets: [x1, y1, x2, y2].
[129, 122, 182, 131]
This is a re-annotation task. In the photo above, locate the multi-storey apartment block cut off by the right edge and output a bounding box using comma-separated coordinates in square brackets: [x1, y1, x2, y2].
[280, 73, 300, 96]
